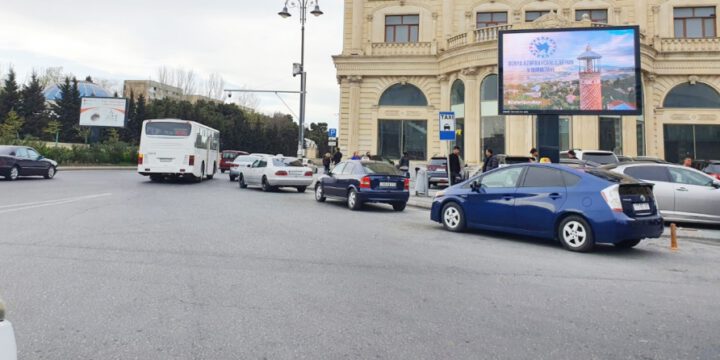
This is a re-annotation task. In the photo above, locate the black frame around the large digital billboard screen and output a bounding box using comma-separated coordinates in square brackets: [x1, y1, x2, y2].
[498, 25, 644, 116]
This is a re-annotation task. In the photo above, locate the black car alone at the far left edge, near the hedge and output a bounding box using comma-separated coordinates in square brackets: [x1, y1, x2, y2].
[0, 146, 57, 181]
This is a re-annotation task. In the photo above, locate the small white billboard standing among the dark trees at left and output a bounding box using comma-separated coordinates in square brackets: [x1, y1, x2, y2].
[80, 97, 127, 127]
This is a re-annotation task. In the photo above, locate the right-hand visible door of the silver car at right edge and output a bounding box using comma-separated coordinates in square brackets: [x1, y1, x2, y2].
[668, 167, 720, 222]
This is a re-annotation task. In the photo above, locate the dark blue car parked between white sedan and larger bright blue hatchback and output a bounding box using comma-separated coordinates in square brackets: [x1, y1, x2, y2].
[315, 160, 410, 211]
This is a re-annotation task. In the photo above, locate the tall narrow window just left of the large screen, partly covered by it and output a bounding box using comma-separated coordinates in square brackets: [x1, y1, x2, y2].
[480, 74, 505, 154]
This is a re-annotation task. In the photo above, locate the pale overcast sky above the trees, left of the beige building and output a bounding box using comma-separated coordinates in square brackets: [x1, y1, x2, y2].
[0, 0, 343, 129]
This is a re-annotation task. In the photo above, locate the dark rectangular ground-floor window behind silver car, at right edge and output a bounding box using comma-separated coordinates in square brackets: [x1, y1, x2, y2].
[663, 124, 720, 163]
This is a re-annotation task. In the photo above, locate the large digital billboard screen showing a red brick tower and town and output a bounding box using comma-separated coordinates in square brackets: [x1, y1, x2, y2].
[498, 26, 642, 115]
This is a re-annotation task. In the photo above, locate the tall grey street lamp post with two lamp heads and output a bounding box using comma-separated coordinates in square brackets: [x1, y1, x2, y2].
[278, 0, 323, 158]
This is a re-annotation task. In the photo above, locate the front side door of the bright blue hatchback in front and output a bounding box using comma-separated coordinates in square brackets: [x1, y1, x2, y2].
[465, 166, 525, 229]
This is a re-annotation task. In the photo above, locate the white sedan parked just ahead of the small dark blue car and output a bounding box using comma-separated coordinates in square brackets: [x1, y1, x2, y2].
[238, 156, 313, 192]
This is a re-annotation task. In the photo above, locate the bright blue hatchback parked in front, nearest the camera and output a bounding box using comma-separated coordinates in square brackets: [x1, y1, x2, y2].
[431, 164, 663, 252]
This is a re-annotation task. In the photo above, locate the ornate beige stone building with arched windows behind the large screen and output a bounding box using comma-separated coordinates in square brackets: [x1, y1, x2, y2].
[334, 0, 720, 163]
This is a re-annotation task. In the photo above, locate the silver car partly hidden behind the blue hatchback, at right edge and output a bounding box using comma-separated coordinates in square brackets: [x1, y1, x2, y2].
[612, 163, 720, 224]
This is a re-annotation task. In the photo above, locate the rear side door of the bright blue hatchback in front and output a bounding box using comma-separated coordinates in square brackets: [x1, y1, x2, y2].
[514, 166, 567, 236]
